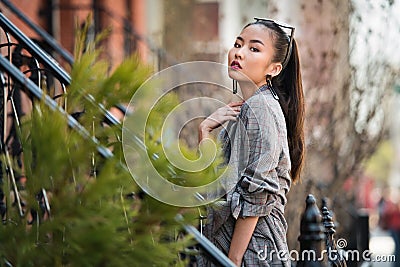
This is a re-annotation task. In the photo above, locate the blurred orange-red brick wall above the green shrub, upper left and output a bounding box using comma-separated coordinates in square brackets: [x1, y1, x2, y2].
[0, 0, 146, 66]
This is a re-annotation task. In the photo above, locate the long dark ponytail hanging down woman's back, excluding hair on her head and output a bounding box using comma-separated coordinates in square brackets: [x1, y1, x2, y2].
[272, 40, 305, 182]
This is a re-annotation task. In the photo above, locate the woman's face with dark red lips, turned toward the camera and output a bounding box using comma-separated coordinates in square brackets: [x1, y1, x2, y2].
[228, 24, 282, 87]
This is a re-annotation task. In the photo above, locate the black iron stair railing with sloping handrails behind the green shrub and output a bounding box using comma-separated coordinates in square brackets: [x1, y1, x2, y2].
[0, 8, 234, 266]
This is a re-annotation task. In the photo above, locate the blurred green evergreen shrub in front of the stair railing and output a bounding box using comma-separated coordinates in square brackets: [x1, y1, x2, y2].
[0, 24, 200, 267]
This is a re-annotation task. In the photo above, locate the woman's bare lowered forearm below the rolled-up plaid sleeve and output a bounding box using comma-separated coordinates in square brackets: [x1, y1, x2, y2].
[228, 217, 258, 266]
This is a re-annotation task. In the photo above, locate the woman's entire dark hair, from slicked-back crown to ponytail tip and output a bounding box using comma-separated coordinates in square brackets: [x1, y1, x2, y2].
[245, 19, 305, 182]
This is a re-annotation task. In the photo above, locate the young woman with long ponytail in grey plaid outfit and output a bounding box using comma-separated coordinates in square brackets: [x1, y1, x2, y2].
[198, 19, 304, 266]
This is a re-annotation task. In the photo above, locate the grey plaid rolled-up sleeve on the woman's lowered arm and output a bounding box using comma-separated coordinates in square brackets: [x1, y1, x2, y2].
[231, 94, 286, 218]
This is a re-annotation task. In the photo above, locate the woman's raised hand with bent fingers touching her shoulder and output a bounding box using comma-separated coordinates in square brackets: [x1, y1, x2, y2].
[199, 101, 244, 142]
